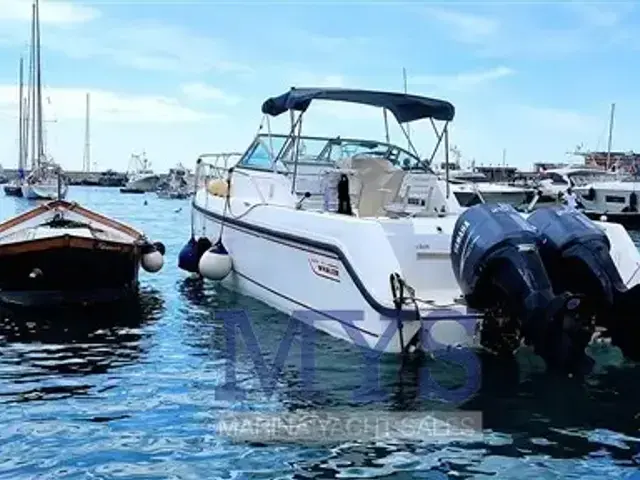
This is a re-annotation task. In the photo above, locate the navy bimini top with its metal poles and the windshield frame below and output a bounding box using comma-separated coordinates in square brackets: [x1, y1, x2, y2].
[236, 88, 454, 198]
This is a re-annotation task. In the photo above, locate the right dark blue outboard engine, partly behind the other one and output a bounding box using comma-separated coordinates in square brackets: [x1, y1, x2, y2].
[528, 207, 640, 359]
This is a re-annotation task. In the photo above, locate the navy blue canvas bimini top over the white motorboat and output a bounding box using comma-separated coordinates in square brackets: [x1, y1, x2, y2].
[262, 88, 455, 123]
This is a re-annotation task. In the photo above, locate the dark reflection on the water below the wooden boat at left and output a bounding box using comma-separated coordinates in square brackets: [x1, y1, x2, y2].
[0, 288, 163, 403]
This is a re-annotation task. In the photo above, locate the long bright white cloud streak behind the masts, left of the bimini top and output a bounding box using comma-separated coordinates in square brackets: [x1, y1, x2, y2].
[0, 85, 219, 123]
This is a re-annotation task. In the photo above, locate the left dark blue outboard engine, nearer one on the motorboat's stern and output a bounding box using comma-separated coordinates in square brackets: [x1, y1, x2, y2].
[451, 204, 591, 372]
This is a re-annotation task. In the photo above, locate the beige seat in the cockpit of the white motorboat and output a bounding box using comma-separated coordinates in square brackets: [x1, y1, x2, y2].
[350, 155, 406, 217]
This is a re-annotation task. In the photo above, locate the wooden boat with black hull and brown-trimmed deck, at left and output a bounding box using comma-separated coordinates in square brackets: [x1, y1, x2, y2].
[0, 199, 165, 307]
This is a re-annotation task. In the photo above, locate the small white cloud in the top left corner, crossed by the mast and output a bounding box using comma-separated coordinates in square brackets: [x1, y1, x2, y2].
[0, 0, 100, 24]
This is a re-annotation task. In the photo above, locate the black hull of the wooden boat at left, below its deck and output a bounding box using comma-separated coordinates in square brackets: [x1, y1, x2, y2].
[0, 236, 140, 306]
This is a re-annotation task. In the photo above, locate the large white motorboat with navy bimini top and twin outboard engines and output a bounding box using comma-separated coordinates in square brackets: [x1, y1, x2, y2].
[179, 88, 640, 368]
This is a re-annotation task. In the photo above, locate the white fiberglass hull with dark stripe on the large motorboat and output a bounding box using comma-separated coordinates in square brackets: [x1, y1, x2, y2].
[193, 191, 480, 353]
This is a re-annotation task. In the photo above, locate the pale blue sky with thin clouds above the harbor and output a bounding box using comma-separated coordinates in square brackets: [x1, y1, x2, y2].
[0, 0, 640, 171]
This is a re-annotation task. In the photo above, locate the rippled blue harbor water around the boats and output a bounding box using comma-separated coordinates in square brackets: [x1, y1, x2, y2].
[0, 187, 640, 480]
